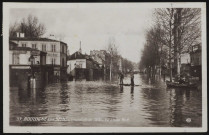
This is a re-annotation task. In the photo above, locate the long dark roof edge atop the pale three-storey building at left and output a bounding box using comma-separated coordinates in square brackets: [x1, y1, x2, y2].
[9, 37, 67, 45]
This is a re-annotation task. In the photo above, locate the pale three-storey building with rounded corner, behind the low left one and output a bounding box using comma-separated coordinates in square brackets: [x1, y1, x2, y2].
[10, 37, 67, 80]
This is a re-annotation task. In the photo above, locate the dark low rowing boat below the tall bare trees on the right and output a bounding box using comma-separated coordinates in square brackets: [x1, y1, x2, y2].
[166, 81, 197, 88]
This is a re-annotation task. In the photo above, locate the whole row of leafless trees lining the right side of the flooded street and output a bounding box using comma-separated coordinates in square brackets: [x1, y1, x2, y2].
[139, 8, 201, 81]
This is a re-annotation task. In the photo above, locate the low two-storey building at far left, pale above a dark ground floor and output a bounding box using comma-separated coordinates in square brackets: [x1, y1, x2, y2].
[9, 41, 47, 89]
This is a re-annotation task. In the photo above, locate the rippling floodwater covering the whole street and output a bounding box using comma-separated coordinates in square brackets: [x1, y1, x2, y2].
[10, 74, 202, 127]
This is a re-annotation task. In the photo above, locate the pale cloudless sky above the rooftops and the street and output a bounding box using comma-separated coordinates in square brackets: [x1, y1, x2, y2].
[9, 5, 153, 62]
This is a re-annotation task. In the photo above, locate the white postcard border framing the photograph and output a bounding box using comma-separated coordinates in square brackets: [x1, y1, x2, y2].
[3, 2, 207, 133]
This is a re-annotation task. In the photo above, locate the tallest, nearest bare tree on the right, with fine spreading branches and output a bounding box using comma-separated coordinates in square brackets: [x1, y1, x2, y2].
[155, 8, 201, 81]
